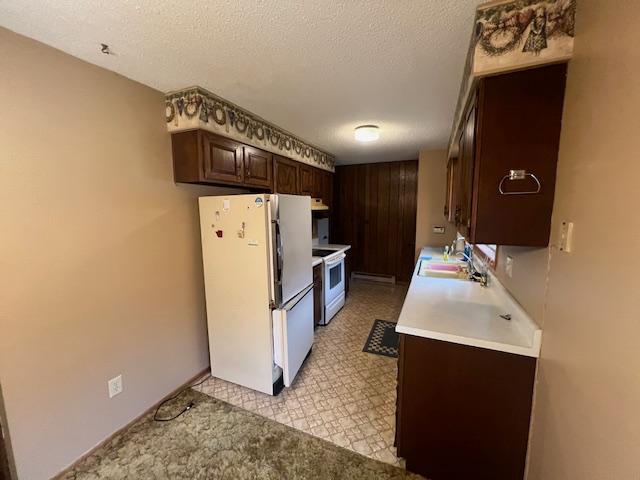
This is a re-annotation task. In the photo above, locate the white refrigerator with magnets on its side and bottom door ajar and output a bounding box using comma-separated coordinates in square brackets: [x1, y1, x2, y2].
[199, 194, 313, 395]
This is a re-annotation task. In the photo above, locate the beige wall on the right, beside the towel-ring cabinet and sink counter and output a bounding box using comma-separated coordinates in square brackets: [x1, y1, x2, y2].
[484, 0, 640, 480]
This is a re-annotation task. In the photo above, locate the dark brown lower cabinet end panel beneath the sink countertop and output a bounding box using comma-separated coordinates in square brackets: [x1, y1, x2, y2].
[396, 334, 536, 480]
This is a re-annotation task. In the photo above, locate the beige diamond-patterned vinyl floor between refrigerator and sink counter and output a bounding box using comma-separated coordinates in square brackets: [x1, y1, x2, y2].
[195, 281, 407, 467]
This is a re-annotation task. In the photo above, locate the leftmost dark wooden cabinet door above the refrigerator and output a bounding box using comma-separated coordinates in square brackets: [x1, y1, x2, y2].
[202, 132, 244, 183]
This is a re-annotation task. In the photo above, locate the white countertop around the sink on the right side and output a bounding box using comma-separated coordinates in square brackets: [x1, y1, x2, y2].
[396, 247, 542, 357]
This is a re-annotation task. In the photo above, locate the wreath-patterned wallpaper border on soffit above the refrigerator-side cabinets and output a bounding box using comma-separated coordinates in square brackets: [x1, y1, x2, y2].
[165, 87, 335, 171]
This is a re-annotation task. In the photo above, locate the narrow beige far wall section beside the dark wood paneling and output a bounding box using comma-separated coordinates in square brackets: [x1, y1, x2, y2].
[416, 150, 456, 256]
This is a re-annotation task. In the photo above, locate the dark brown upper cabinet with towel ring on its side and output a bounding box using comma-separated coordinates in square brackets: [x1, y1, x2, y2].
[445, 64, 566, 247]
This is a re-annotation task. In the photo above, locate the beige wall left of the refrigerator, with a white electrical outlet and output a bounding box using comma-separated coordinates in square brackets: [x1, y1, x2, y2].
[0, 29, 238, 480]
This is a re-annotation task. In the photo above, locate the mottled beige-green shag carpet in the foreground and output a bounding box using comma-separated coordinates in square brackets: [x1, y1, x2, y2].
[60, 390, 420, 480]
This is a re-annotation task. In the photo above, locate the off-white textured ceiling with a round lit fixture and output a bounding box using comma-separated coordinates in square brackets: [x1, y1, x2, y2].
[0, 0, 480, 164]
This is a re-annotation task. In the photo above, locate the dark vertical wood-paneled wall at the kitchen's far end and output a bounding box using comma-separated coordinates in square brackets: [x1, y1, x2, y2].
[331, 160, 418, 281]
